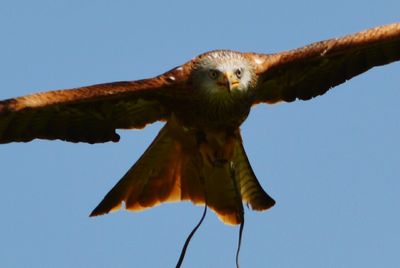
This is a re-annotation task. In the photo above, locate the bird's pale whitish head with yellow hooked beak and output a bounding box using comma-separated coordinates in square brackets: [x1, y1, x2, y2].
[193, 50, 255, 97]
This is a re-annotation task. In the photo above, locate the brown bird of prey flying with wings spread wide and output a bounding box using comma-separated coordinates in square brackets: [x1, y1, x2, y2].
[0, 23, 400, 224]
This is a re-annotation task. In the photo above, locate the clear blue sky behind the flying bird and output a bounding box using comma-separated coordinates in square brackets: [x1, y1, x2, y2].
[0, 0, 400, 268]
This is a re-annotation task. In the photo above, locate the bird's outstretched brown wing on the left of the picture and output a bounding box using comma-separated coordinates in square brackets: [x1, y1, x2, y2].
[0, 66, 186, 143]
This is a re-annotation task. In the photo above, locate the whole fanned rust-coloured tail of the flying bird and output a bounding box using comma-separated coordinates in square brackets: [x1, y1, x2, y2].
[90, 121, 275, 224]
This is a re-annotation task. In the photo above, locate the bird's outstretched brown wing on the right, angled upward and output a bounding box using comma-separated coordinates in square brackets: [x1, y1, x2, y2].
[247, 23, 400, 103]
